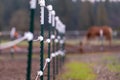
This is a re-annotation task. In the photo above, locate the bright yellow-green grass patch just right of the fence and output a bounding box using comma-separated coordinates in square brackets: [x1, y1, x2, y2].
[62, 62, 96, 80]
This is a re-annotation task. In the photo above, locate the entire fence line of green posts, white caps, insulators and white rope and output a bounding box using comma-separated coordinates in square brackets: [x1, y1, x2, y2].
[0, 0, 65, 80]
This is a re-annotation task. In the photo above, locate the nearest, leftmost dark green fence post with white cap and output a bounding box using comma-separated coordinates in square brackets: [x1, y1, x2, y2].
[26, 0, 36, 80]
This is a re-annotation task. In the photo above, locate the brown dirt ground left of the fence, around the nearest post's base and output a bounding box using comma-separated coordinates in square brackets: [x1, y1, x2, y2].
[0, 54, 39, 80]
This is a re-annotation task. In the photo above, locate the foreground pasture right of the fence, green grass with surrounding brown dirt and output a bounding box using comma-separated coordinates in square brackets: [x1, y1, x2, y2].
[58, 53, 120, 80]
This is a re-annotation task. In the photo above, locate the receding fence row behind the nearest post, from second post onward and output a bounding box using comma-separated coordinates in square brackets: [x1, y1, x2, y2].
[36, 0, 65, 80]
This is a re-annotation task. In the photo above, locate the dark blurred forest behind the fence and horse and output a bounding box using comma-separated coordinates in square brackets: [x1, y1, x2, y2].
[0, 0, 120, 31]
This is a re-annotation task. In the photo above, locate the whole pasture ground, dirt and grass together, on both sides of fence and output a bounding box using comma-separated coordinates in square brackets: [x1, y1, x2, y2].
[0, 40, 120, 80]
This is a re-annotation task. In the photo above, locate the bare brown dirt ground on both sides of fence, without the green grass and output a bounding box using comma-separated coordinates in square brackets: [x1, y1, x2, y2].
[0, 46, 120, 80]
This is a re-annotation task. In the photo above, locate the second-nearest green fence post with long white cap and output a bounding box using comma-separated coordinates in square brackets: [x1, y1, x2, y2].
[39, 0, 45, 80]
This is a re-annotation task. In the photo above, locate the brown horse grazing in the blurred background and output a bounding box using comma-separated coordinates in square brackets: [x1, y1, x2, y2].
[83, 26, 113, 45]
